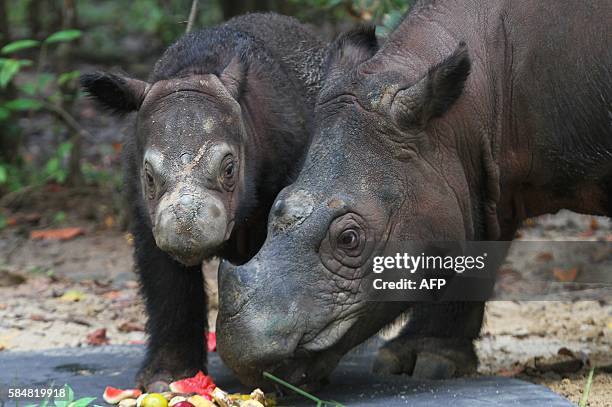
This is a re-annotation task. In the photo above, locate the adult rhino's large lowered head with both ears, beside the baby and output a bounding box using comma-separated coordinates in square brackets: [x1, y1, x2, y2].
[218, 26, 498, 384]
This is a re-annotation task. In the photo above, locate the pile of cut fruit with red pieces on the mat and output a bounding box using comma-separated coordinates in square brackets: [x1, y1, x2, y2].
[103, 372, 274, 407]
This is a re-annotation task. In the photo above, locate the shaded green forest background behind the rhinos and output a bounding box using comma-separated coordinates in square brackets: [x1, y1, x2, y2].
[0, 0, 411, 229]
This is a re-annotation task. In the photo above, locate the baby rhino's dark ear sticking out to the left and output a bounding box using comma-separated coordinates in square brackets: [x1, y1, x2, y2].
[80, 72, 149, 114]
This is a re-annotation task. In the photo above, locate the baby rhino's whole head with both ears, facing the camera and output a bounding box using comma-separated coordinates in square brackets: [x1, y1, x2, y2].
[81, 58, 249, 266]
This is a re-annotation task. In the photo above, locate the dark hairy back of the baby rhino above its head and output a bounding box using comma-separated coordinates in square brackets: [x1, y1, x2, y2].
[150, 13, 325, 106]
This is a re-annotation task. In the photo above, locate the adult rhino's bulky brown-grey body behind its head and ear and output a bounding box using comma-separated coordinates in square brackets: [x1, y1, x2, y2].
[380, 0, 612, 204]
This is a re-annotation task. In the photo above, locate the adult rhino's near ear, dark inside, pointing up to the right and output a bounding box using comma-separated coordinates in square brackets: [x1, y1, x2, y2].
[391, 42, 471, 128]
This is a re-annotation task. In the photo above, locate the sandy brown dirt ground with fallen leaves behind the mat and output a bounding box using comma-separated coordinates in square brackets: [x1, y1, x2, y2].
[0, 188, 612, 406]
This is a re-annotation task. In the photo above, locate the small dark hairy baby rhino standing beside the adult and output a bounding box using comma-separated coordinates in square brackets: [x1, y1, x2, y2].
[81, 14, 324, 389]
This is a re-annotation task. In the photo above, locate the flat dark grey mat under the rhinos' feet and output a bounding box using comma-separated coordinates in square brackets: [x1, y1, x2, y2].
[0, 346, 573, 407]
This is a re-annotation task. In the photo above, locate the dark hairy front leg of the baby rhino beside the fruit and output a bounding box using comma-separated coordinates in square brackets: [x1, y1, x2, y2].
[133, 212, 206, 391]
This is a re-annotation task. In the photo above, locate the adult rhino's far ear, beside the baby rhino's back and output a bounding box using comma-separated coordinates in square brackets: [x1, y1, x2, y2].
[325, 25, 378, 77]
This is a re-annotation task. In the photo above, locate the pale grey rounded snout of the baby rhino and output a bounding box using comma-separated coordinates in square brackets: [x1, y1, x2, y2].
[153, 192, 232, 266]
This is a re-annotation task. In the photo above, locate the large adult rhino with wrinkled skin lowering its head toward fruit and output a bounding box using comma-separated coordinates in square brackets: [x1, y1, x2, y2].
[217, 0, 612, 385]
